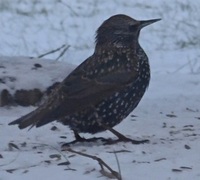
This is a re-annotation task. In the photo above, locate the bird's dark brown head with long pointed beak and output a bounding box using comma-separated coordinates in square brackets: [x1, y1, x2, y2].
[96, 14, 160, 48]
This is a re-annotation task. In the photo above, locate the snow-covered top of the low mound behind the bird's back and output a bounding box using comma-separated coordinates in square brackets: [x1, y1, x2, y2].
[0, 57, 76, 93]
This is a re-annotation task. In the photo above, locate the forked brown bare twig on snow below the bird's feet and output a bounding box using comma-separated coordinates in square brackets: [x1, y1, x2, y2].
[64, 147, 121, 180]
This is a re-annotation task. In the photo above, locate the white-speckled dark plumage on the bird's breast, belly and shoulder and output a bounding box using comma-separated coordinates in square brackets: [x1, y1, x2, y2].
[62, 48, 150, 133]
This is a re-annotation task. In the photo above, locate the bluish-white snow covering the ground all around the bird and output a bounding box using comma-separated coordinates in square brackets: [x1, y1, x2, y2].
[0, 0, 200, 180]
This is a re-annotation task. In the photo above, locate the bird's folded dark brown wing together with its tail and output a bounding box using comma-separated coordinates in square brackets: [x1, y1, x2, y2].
[10, 52, 138, 128]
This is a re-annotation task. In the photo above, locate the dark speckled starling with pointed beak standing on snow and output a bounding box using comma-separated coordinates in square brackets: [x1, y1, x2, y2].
[9, 14, 161, 144]
